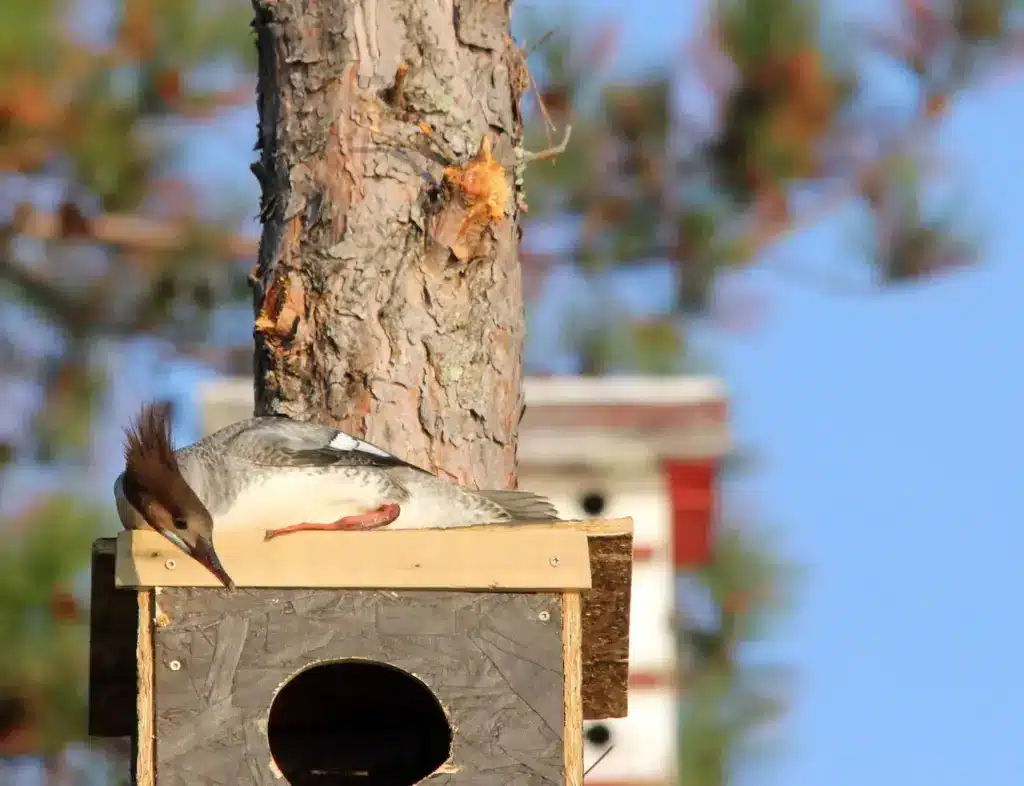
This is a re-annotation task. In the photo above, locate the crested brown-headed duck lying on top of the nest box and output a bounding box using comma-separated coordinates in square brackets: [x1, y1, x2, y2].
[114, 404, 559, 588]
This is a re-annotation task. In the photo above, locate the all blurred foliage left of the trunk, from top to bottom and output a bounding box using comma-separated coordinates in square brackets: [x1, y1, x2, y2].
[0, 0, 255, 769]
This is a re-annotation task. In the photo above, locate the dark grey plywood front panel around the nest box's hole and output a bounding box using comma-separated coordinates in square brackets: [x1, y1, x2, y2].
[155, 588, 563, 786]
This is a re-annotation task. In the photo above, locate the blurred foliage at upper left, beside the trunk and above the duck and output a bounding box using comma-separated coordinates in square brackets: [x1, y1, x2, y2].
[0, 0, 255, 461]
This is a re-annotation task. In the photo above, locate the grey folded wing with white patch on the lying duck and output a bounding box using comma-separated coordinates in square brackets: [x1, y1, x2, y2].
[221, 418, 429, 474]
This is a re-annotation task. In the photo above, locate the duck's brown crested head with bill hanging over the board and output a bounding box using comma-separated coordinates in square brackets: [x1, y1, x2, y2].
[116, 404, 234, 588]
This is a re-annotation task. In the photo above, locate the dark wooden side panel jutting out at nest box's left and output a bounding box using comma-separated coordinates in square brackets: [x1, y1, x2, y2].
[88, 537, 138, 737]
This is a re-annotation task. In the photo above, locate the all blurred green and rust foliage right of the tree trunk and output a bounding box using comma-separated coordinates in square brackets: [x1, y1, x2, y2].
[516, 0, 1016, 786]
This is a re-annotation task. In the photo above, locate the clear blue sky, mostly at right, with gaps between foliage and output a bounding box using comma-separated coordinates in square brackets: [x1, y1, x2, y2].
[74, 0, 1024, 786]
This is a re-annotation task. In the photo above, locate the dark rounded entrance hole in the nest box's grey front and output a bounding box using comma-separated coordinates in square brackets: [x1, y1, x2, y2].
[267, 660, 452, 786]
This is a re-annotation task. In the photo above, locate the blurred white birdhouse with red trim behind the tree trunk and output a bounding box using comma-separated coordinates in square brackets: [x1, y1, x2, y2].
[202, 377, 730, 786]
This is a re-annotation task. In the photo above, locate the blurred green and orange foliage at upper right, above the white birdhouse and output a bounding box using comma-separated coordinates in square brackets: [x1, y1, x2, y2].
[516, 0, 1016, 369]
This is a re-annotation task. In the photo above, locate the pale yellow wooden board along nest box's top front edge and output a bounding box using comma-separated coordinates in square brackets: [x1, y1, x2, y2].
[117, 526, 590, 591]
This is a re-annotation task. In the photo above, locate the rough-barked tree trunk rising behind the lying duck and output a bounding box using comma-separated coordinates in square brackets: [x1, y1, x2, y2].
[253, 0, 524, 488]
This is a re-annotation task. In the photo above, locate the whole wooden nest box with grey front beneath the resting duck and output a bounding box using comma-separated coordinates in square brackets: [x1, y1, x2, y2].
[89, 519, 633, 786]
